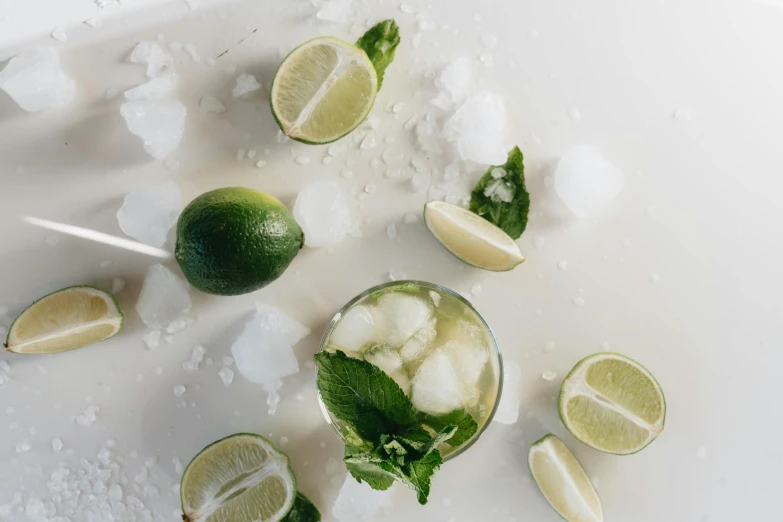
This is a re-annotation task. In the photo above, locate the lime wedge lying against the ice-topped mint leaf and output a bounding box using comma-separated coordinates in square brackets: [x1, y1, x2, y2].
[424, 201, 525, 272]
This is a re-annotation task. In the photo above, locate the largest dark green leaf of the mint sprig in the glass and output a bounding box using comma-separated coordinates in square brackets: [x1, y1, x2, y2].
[315, 351, 418, 443]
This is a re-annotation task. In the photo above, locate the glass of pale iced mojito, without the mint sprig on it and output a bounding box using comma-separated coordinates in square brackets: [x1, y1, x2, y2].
[319, 281, 503, 460]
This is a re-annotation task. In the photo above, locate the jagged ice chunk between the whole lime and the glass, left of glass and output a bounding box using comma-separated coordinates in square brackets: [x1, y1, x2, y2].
[231, 304, 310, 384]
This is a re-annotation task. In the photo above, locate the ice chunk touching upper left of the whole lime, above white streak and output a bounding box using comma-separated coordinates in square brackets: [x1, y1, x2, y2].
[117, 180, 182, 247]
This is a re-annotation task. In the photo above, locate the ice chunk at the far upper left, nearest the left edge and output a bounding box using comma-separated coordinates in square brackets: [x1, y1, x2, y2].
[0, 47, 76, 112]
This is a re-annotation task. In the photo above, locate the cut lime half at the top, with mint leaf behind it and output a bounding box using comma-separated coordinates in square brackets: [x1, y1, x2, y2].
[271, 36, 378, 143]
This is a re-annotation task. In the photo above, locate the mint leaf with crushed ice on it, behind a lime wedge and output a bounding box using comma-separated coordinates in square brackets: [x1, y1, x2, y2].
[470, 147, 530, 239]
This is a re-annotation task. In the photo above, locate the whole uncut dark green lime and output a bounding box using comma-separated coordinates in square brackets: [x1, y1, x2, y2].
[174, 187, 304, 295]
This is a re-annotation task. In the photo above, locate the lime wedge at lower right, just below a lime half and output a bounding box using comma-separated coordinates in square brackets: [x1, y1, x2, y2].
[527, 434, 604, 522]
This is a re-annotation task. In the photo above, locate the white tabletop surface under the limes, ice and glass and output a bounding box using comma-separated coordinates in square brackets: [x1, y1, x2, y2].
[0, 0, 783, 522]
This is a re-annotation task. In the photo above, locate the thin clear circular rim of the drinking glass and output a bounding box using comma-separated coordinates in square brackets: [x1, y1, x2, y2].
[315, 279, 503, 462]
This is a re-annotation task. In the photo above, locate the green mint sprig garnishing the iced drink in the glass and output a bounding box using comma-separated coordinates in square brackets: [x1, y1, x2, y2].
[315, 351, 478, 504]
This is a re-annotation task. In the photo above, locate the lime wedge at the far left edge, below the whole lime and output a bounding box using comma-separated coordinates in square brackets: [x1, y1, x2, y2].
[5, 286, 122, 353]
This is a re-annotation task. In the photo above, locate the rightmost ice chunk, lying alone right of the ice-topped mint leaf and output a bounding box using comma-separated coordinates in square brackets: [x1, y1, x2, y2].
[555, 145, 624, 217]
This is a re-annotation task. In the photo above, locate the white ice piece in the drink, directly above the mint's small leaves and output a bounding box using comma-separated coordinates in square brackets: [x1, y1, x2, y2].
[411, 349, 464, 414]
